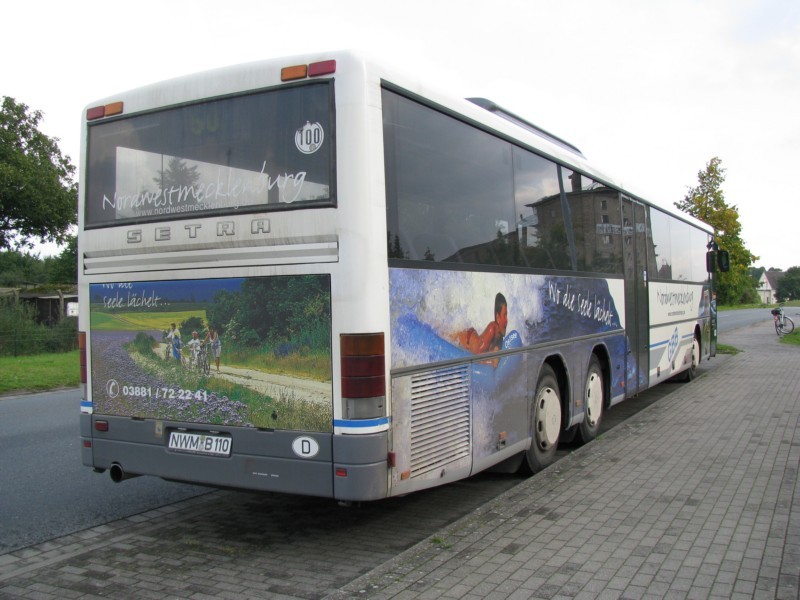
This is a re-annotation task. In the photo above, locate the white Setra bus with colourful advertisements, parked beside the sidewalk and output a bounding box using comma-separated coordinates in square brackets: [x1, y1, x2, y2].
[79, 53, 716, 501]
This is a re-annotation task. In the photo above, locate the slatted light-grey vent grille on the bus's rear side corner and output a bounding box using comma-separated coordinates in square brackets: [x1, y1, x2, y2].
[411, 365, 470, 478]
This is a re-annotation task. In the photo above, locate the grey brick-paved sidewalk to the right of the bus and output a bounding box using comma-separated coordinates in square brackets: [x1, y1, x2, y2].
[328, 323, 800, 600]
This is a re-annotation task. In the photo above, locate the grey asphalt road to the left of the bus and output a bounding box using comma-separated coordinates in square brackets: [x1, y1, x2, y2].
[0, 389, 209, 554]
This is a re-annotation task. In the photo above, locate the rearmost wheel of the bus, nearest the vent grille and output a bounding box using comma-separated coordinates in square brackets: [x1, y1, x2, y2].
[525, 365, 561, 473]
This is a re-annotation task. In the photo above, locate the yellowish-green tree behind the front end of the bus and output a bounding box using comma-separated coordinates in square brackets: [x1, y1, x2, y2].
[675, 157, 758, 304]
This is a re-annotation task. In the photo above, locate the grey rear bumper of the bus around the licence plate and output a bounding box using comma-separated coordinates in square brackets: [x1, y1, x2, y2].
[80, 414, 388, 501]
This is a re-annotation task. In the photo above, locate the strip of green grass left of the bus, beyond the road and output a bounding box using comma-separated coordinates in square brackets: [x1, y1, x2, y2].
[0, 350, 80, 394]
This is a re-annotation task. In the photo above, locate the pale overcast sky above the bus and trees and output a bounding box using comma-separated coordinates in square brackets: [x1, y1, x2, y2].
[6, 0, 800, 269]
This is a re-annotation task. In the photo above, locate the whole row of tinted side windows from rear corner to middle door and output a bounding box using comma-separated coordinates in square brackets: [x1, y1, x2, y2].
[383, 90, 622, 274]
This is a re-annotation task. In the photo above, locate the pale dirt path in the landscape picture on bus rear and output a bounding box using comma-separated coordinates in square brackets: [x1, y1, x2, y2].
[157, 344, 333, 406]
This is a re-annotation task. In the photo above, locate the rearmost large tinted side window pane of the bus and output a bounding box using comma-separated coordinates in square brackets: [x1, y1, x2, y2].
[383, 90, 515, 265]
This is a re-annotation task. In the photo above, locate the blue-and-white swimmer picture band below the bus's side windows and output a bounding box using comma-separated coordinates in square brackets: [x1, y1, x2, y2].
[390, 269, 625, 369]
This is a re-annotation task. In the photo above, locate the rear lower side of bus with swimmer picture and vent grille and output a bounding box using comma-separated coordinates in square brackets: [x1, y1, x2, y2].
[390, 269, 624, 494]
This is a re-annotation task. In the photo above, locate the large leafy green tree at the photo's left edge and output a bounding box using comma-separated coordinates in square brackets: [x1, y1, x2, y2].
[0, 96, 78, 248]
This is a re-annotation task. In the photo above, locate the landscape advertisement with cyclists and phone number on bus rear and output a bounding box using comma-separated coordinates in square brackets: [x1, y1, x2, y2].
[90, 275, 333, 432]
